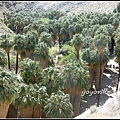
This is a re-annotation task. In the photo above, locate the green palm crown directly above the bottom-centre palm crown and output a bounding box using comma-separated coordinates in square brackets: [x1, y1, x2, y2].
[41, 66, 64, 96]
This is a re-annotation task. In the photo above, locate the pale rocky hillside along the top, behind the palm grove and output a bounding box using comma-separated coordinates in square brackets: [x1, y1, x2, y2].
[0, 1, 119, 17]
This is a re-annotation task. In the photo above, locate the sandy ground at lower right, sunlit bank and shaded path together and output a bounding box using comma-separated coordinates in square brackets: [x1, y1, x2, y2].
[74, 57, 120, 119]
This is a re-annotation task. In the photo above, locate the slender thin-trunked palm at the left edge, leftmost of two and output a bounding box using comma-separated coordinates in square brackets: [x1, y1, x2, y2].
[0, 33, 13, 70]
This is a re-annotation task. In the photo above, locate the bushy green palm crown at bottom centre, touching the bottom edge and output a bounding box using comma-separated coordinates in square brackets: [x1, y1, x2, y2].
[44, 90, 73, 118]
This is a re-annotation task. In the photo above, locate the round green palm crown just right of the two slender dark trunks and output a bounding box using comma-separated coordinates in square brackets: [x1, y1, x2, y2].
[20, 58, 42, 84]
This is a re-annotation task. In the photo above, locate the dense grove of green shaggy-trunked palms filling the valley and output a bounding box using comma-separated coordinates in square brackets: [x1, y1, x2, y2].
[0, 4, 120, 118]
